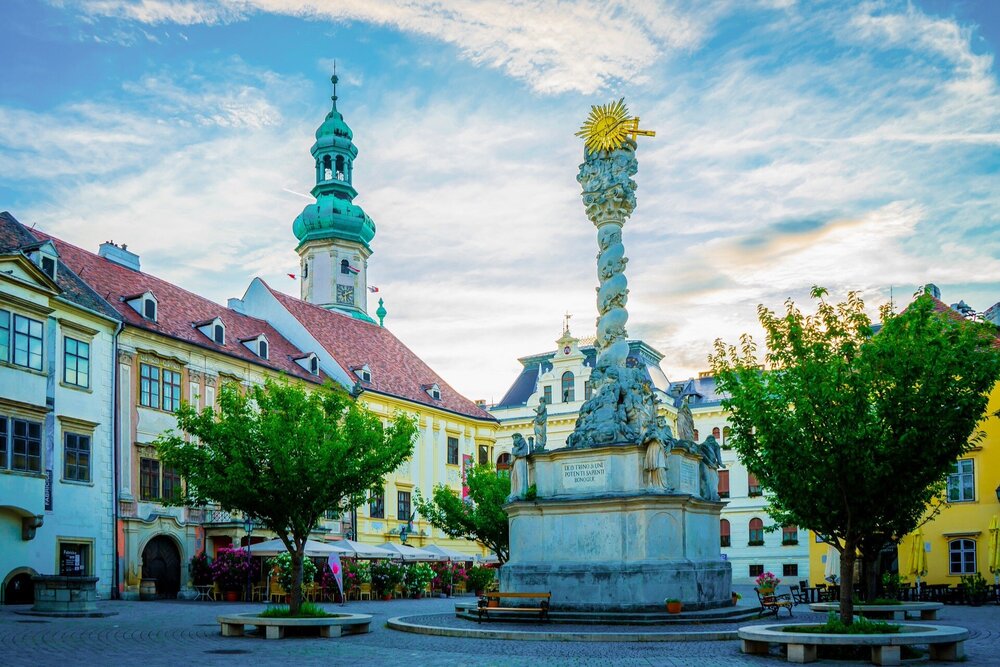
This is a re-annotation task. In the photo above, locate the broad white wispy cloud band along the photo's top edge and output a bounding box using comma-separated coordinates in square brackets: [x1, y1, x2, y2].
[72, 0, 726, 93]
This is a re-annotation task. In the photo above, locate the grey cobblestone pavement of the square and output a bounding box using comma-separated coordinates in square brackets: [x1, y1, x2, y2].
[0, 599, 1000, 667]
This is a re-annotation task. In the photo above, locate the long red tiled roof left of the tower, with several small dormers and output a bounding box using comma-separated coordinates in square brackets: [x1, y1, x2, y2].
[34, 229, 323, 382]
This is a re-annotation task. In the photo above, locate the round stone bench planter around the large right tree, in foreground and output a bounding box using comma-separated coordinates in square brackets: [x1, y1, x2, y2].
[739, 624, 969, 665]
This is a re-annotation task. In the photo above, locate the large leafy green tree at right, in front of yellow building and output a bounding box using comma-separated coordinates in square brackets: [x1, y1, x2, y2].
[710, 287, 1000, 624]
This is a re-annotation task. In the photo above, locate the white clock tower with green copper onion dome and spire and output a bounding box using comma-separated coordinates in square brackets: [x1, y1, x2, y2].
[292, 74, 375, 322]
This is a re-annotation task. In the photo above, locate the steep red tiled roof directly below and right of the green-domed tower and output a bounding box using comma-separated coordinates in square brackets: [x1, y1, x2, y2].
[261, 281, 496, 421]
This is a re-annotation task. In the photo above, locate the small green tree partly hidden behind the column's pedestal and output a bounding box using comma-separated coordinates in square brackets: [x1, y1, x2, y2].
[414, 465, 510, 563]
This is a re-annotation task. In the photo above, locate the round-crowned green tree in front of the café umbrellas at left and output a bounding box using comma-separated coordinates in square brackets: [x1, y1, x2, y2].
[156, 380, 416, 614]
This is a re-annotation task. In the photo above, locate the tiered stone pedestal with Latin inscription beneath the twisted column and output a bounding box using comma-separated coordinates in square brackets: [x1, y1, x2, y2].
[500, 445, 732, 612]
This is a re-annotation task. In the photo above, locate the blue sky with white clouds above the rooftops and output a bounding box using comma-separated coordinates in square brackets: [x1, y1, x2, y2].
[0, 0, 1000, 401]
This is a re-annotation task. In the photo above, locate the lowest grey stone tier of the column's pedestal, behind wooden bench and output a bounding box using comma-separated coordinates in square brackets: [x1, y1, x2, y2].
[500, 561, 732, 612]
